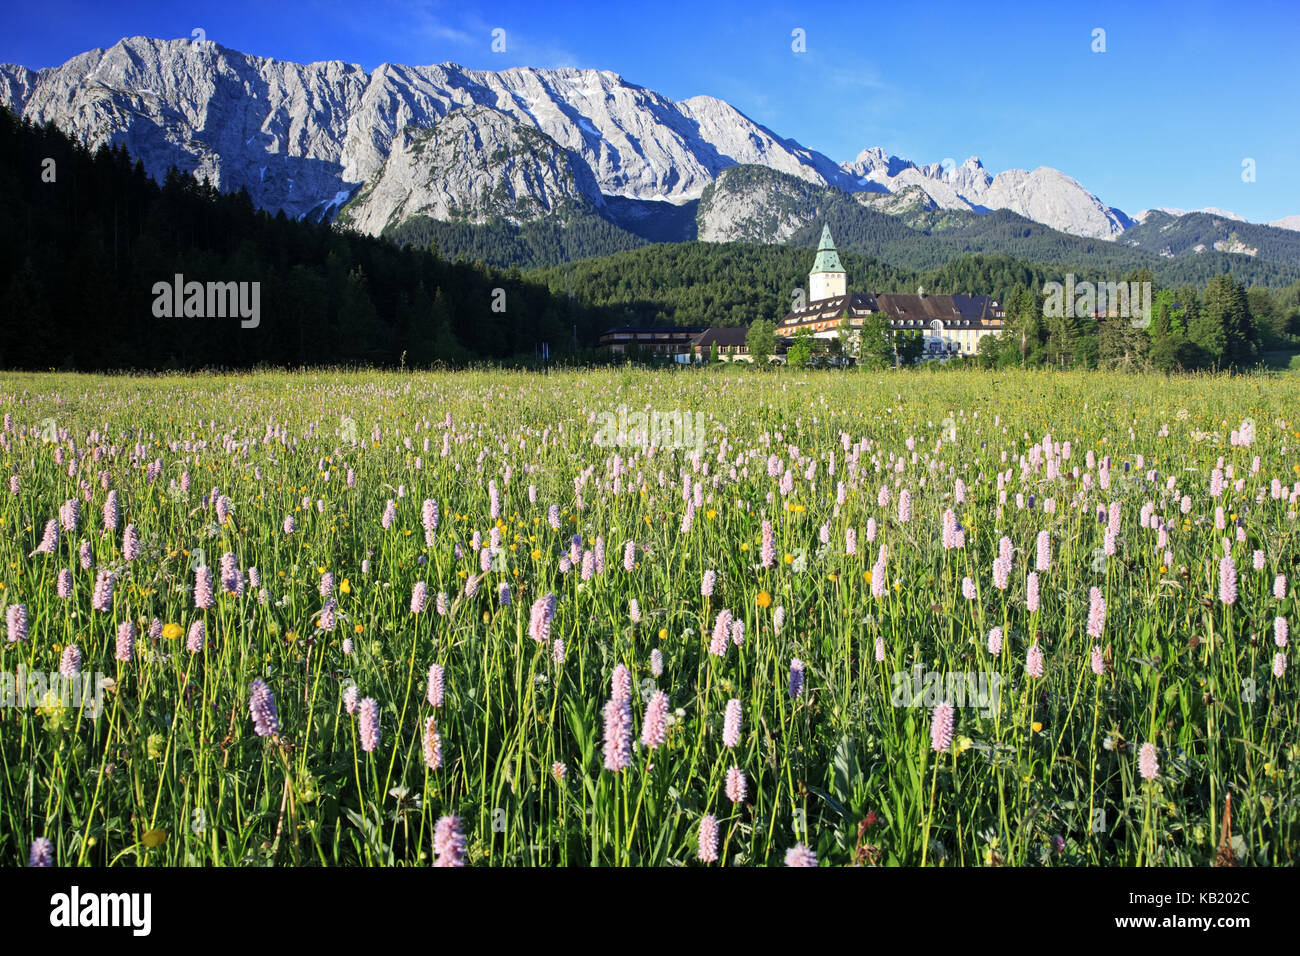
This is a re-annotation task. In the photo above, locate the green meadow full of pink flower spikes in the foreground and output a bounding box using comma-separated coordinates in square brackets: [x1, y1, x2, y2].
[0, 369, 1300, 866]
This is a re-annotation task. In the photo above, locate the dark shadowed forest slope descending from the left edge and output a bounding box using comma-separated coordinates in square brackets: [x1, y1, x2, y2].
[0, 111, 608, 371]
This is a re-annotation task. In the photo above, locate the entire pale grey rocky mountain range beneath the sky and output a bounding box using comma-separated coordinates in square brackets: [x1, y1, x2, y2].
[0, 36, 1300, 252]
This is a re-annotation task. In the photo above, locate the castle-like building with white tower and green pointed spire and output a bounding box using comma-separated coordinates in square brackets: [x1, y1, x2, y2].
[776, 225, 1002, 360]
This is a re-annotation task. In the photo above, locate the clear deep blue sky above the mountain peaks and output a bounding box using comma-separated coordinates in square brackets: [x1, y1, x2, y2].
[0, 0, 1300, 221]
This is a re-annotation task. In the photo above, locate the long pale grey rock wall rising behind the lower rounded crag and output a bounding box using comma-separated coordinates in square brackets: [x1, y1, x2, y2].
[0, 36, 846, 228]
